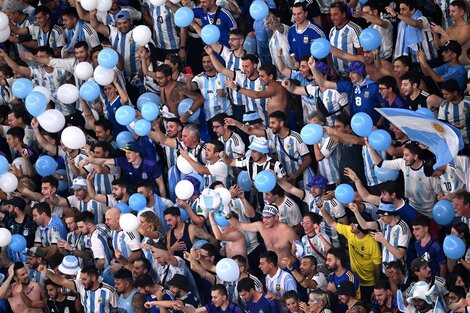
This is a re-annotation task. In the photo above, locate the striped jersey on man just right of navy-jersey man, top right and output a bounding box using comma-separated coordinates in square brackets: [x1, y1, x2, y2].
[329, 21, 362, 75]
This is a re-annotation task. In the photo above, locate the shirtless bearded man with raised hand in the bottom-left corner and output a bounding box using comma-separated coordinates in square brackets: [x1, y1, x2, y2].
[0, 262, 47, 313]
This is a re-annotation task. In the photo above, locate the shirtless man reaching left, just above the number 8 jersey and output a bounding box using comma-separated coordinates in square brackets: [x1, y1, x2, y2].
[331, 46, 393, 81]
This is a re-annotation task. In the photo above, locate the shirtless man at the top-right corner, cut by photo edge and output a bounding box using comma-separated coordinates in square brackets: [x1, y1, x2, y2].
[431, 0, 470, 65]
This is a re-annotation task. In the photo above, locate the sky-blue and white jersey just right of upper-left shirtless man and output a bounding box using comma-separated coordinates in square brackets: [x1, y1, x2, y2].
[192, 72, 232, 121]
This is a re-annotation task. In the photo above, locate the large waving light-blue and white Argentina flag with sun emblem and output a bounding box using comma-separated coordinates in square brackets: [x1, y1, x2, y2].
[376, 108, 461, 169]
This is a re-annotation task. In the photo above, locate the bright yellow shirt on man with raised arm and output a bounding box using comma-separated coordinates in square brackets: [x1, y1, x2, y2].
[336, 223, 382, 286]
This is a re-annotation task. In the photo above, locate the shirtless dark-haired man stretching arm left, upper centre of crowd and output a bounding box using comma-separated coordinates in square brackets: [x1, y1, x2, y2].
[227, 64, 287, 116]
